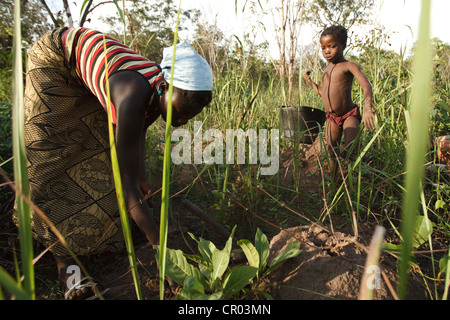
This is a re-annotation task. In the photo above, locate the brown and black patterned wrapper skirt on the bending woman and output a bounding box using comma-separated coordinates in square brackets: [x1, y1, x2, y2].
[20, 29, 123, 256]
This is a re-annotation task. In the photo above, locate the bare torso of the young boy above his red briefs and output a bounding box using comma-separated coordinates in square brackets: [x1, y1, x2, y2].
[319, 61, 355, 116]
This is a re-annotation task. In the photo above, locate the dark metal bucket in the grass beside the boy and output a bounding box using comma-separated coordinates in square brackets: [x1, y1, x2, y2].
[279, 106, 326, 144]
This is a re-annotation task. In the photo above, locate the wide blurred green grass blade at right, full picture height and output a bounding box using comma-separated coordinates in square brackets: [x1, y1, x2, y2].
[399, 0, 432, 299]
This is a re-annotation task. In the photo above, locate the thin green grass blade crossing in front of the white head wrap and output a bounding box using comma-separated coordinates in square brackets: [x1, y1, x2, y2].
[158, 0, 181, 300]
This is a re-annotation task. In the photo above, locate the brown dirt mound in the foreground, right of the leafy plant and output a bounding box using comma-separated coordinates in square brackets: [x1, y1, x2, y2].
[269, 225, 427, 300]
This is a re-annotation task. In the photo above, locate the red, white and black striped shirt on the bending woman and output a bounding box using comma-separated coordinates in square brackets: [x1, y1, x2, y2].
[62, 28, 162, 124]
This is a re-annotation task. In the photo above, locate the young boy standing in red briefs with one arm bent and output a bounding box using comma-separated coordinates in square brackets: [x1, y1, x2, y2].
[302, 26, 374, 176]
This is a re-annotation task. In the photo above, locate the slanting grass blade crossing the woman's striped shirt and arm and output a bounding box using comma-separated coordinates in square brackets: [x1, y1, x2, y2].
[103, 34, 142, 300]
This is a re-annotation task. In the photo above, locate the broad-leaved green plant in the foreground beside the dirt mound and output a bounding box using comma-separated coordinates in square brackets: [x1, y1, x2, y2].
[155, 227, 301, 300]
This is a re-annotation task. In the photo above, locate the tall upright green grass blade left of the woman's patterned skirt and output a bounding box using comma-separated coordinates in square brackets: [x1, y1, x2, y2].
[12, 0, 35, 299]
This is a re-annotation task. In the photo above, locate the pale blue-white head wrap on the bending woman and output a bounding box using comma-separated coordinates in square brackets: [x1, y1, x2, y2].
[161, 41, 213, 91]
